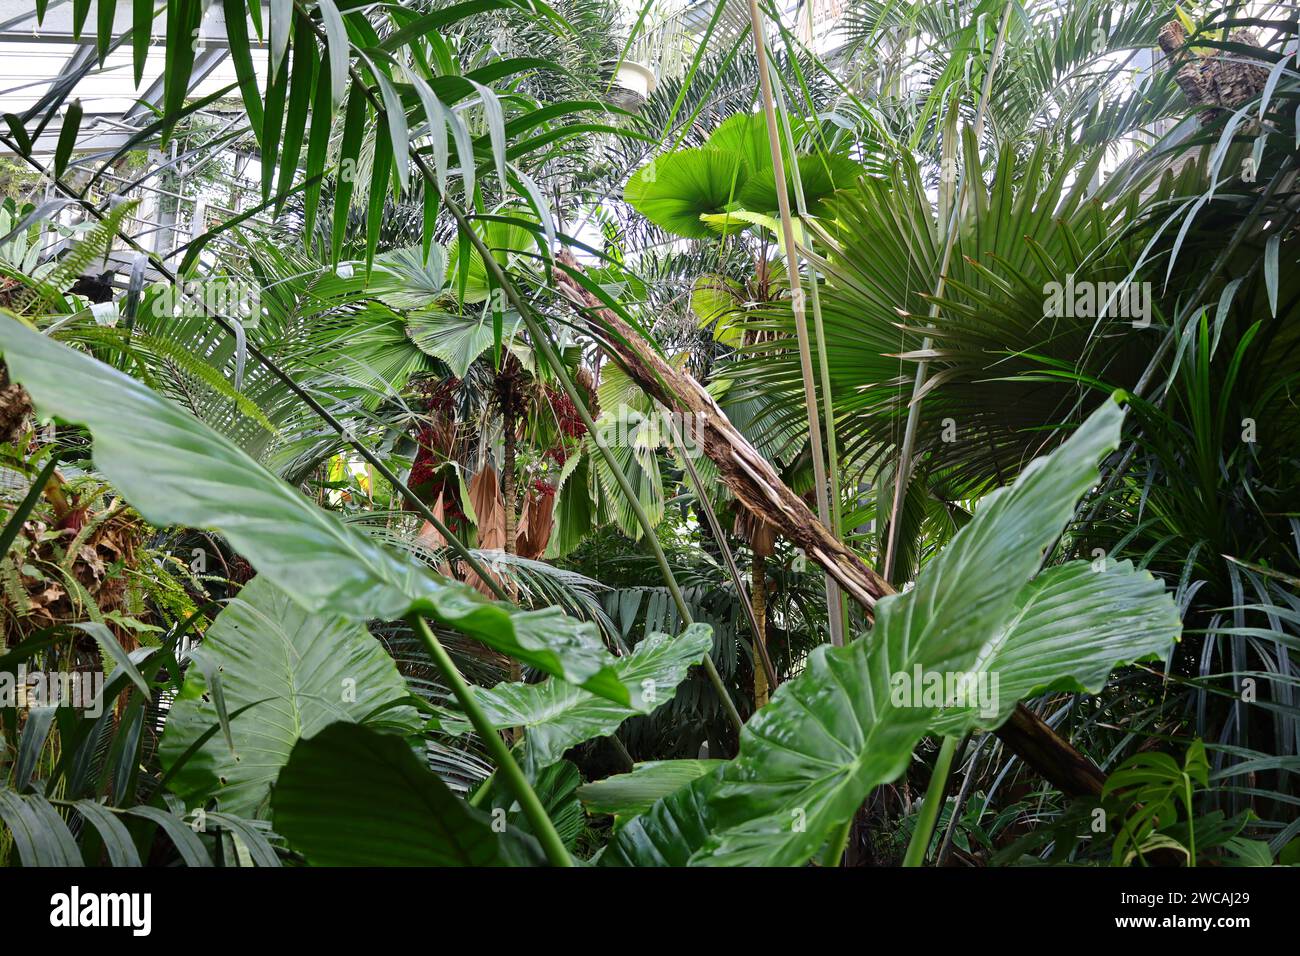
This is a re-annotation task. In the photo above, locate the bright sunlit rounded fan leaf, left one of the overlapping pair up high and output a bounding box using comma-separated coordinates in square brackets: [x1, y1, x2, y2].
[623, 148, 749, 239]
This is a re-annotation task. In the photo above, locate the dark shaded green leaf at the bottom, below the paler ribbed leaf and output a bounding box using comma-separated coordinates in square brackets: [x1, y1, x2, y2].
[270, 723, 503, 866]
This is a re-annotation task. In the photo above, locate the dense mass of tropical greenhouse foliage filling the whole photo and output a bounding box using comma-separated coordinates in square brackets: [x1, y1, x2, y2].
[0, 0, 1300, 866]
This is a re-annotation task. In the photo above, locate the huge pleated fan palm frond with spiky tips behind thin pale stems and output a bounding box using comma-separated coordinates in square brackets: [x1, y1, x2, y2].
[719, 138, 1171, 498]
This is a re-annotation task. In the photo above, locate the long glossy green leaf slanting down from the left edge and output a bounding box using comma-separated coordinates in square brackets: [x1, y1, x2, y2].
[0, 317, 632, 704]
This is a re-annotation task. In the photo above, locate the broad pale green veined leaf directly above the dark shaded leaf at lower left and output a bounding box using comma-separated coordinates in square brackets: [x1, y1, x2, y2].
[160, 576, 421, 817]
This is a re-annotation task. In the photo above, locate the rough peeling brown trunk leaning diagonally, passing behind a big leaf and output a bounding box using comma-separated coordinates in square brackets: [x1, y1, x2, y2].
[555, 252, 1105, 796]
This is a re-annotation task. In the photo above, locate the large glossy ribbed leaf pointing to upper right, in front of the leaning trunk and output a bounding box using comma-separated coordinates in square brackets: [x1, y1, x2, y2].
[693, 401, 1123, 866]
